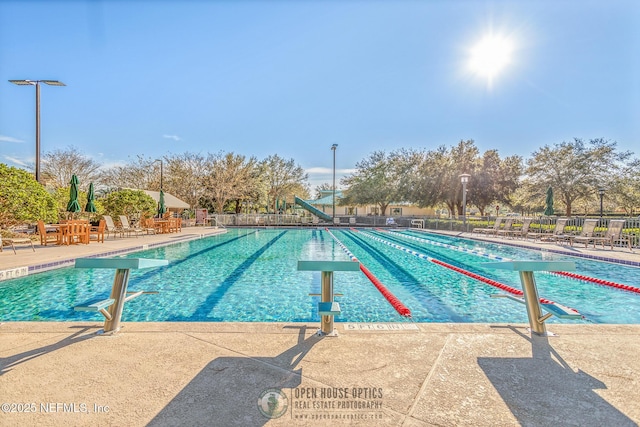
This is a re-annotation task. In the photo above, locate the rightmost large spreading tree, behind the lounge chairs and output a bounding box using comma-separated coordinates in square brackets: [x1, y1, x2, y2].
[524, 138, 631, 216]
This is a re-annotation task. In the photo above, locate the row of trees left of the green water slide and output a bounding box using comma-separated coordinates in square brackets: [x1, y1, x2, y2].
[42, 147, 309, 217]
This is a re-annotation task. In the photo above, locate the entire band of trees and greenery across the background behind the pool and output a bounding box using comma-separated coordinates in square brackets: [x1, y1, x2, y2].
[0, 138, 640, 227]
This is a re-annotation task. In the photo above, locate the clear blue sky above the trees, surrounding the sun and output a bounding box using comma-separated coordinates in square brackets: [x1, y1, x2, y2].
[0, 0, 640, 186]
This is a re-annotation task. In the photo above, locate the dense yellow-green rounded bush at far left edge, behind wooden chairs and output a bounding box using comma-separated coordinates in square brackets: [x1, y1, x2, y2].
[0, 163, 58, 227]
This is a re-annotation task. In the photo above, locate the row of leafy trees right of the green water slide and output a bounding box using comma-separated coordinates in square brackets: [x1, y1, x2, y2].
[341, 138, 640, 216]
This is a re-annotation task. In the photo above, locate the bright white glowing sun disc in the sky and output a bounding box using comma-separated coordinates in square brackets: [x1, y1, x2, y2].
[469, 35, 513, 82]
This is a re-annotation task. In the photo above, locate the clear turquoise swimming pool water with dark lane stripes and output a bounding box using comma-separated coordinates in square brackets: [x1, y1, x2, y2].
[0, 229, 640, 324]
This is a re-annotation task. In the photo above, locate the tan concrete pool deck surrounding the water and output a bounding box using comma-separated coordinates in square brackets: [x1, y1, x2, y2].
[0, 228, 640, 427]
